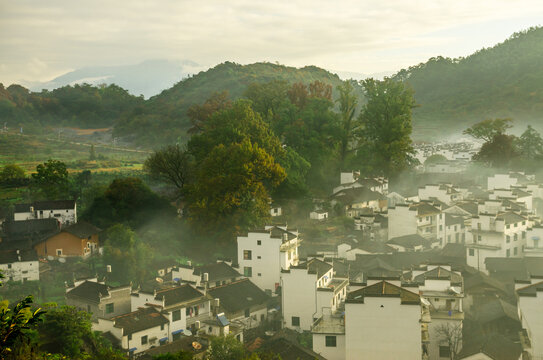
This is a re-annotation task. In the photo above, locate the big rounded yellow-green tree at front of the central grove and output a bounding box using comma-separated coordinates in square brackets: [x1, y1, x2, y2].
[187, 140, 286, 237]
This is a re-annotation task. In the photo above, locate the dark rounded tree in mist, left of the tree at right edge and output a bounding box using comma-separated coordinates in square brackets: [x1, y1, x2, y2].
[473, 134, 518, 167]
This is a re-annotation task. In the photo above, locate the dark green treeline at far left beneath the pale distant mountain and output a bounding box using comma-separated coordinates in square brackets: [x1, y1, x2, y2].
[0, 84, 144, 131]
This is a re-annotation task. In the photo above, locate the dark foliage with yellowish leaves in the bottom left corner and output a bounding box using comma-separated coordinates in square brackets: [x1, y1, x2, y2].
[0, 272, 44, 359]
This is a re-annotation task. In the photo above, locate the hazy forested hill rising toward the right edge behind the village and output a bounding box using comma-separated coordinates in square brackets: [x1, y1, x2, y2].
[395, 27, 543, 134]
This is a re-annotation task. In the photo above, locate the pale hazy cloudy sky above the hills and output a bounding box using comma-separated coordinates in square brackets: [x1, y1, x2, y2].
[0, 0, 543, 84]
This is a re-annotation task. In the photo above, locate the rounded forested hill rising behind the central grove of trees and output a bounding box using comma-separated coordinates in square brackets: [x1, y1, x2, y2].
[115, 62, 354, 146]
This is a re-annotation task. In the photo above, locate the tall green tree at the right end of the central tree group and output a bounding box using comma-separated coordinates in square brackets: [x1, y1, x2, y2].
[359, 78, 416, 177]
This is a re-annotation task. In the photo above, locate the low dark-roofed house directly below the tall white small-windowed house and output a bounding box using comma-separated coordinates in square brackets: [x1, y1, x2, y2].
[208, 279, 270, 329]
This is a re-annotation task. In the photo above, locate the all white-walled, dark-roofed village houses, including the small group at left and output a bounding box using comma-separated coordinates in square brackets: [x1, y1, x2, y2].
[0, 167, 543, 360]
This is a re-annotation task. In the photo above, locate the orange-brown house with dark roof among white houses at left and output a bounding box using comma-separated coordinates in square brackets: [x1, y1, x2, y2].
[34, 221, 101, 258]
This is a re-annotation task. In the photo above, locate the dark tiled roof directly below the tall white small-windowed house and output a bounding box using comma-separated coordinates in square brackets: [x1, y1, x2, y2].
[208, 279, 270, 313]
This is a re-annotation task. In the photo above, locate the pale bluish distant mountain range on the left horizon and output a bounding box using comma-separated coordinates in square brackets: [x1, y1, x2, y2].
[22, 60, 202, 98]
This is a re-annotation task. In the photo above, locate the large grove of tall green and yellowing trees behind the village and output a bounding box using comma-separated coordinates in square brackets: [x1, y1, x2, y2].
[145, 79, 415, 241]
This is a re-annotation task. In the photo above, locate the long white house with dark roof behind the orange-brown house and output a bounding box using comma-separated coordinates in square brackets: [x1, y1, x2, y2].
[13, 200, 77, 225]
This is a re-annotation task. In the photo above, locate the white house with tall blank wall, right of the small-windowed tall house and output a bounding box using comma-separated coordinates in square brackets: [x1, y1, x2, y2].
[281, 259, 349, 331]
